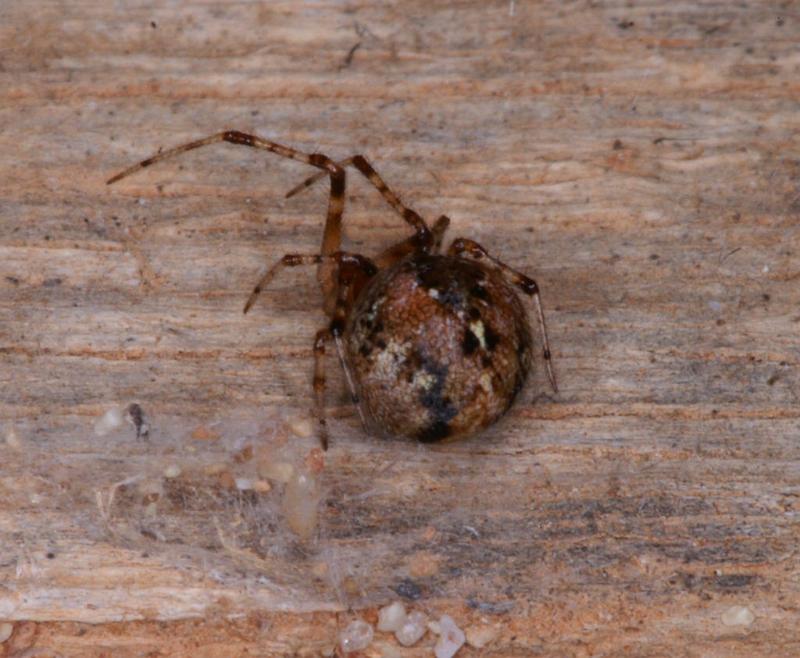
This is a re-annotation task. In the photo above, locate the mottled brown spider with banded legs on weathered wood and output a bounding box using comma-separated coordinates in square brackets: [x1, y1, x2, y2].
[107, 130, 558, 450]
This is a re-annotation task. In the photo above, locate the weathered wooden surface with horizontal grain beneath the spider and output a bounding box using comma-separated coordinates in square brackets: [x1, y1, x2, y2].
[0, 0, 800, 656]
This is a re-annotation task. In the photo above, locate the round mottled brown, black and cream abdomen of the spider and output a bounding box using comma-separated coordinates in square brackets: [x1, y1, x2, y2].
[344, 254, 531, 442]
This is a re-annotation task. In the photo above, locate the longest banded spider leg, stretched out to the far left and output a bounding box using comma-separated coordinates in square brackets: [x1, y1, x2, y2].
[106, 130, 345, 310]
